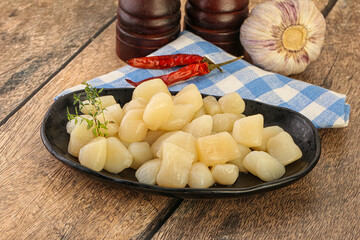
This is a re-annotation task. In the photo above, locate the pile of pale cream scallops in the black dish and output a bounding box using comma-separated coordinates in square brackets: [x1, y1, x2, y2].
[66, 79, 302, 188]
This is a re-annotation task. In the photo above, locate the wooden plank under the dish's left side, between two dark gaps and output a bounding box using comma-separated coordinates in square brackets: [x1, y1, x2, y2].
[0, 20, 178, 239]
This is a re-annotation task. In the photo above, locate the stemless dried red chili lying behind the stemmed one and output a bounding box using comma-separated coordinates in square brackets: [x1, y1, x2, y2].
[126, 54, 212, 69]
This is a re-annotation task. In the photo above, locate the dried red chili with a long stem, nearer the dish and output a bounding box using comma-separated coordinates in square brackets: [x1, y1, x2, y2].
[125, 56, 243, 87]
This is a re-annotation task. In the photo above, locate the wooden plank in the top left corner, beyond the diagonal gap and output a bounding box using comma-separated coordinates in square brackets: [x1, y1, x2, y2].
[0, 0, 117, 122]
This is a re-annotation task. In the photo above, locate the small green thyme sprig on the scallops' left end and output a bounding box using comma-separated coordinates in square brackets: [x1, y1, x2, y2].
[67, 82, 112, 137]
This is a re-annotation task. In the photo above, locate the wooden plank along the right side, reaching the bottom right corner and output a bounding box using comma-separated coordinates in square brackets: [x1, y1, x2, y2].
[154, 0, 360, 239]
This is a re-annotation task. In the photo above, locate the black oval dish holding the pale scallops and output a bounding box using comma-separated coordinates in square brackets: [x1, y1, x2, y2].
[41, 88, 321, 198]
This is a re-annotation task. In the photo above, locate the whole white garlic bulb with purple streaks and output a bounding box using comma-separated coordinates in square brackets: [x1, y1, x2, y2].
[240, 0, 326, 75]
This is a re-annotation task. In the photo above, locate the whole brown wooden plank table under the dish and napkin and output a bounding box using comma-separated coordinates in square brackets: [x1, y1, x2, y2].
[0, 0, 360, 239]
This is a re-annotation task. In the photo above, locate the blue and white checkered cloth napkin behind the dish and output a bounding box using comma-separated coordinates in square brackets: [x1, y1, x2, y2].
[59, 31, 350, 128]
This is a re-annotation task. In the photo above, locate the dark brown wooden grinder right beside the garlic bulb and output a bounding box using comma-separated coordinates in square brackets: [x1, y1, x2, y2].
[185, 0, 249, 56]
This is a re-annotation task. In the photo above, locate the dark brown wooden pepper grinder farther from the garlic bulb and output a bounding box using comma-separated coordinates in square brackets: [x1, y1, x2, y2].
[116, 0, 181, 61]
